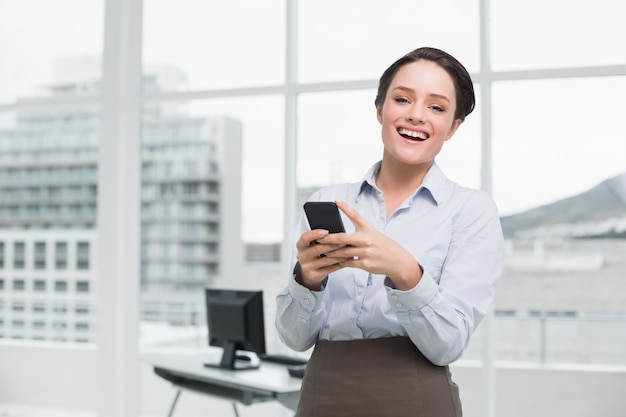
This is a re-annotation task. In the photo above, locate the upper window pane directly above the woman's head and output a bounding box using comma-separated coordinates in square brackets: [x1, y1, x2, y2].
[298, 0, 479, 82]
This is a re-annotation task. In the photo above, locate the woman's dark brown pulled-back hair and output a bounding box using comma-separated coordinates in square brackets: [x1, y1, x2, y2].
[374, 47, 476, 121]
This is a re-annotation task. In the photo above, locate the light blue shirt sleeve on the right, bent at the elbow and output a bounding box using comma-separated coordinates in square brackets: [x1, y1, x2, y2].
[387, 193, 504, 365]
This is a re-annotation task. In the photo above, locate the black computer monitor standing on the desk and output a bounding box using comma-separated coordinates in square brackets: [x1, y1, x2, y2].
[205, 288, 265, 370]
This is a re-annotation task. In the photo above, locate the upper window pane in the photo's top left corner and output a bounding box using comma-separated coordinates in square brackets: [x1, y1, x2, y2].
[0, 0, 104, 103]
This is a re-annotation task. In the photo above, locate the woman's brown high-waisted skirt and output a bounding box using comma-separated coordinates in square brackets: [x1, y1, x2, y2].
[296, 337, 462, 417]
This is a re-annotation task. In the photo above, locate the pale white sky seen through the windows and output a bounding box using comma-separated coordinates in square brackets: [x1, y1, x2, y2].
[0, 0, 626, 242]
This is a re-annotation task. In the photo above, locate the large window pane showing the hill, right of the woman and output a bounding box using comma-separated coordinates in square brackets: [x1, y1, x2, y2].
[493, 77, 626, 364]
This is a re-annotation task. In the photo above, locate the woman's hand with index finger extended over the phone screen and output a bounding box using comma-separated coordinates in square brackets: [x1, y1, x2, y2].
[314, 200, 422, 290]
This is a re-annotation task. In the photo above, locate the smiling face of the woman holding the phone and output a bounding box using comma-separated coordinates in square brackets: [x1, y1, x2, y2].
[376, 60, 461, 167]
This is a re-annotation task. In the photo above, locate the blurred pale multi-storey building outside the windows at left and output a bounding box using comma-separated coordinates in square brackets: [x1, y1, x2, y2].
[0, 61, 244, 342]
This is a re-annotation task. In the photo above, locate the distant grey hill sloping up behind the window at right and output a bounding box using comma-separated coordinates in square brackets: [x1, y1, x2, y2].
[501, 172, 626, 238]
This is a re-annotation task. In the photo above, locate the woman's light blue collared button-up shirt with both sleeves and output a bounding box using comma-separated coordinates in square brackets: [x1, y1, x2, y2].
[276, 162, 504, 365]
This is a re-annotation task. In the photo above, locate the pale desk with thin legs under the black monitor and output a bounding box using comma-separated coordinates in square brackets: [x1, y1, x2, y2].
[145, 352, 302, 417]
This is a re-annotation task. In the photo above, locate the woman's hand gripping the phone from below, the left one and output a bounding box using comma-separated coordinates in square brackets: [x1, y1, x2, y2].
[296, 229, 347, 291]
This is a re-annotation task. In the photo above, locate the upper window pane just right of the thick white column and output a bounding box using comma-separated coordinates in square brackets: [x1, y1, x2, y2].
[143, 0, 285, 91]
